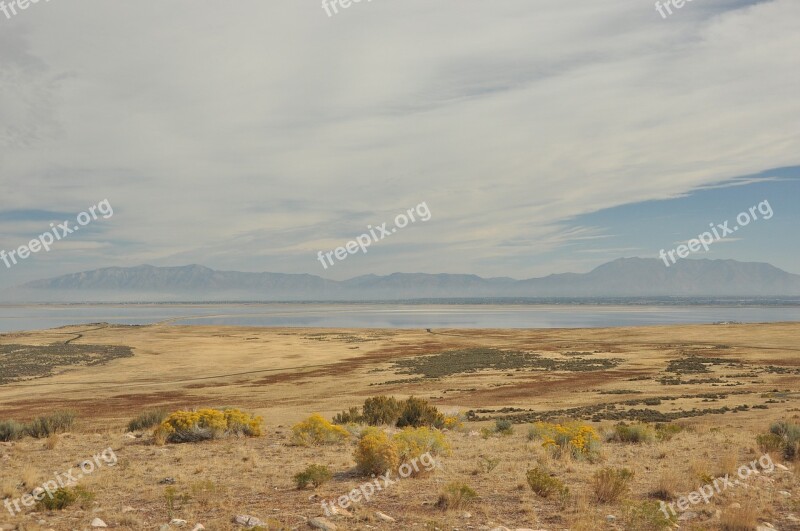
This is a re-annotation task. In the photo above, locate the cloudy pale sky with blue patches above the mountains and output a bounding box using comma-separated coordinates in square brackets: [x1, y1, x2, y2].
[0, 0, 800, 288]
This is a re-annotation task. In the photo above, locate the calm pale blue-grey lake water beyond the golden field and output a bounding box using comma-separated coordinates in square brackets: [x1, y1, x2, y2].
[0, 303, 800, 332]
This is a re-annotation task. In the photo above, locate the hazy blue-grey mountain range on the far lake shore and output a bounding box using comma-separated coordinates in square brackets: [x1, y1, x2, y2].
[5, 258, 800, 302]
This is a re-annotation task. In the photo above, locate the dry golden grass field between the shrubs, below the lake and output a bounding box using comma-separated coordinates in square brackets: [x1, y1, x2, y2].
[0, 323, 800, 531]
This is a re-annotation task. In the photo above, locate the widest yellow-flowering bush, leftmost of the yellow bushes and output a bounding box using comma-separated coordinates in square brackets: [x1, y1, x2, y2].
[153, 409, 263, 444]
